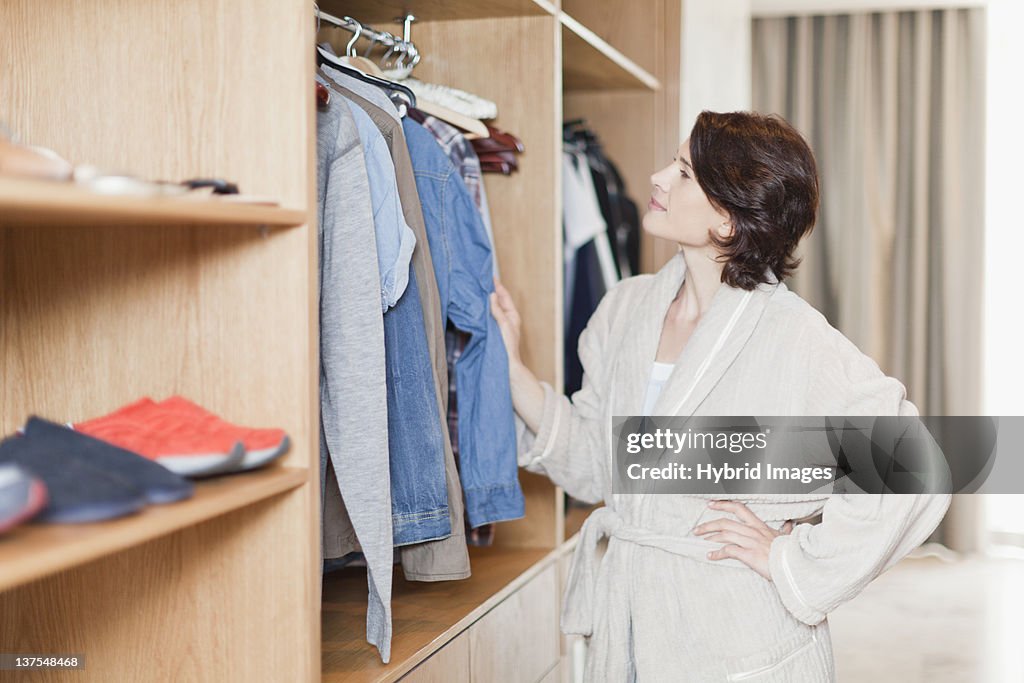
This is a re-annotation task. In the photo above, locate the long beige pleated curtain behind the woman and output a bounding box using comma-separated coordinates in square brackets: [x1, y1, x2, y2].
[752, 9, 985, 550]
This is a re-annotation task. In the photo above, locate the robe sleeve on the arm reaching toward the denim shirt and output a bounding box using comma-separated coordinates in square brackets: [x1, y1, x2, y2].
[515, 287, 620, 503]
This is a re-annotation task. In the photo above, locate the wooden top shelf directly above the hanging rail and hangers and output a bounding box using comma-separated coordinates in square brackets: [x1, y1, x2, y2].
[317, 0, 558, 24]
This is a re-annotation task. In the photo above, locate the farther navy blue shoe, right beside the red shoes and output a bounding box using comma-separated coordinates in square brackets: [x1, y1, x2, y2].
[25, 417, 194, 505]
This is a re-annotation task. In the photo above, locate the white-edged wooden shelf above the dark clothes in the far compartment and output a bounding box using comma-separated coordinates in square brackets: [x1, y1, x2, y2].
[558, 12, 662, 91]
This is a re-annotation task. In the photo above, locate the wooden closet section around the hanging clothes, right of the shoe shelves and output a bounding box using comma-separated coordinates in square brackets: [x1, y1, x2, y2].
[311, 0, 679, 683]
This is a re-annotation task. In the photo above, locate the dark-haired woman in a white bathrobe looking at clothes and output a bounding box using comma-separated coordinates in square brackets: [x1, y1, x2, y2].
[492, 112, 950, 683]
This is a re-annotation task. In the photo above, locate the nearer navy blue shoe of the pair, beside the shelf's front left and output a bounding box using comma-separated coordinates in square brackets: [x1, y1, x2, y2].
[0, 436, 145, 523]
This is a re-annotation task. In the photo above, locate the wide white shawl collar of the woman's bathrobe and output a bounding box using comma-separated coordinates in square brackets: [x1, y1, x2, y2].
[612, 251, 785, 416]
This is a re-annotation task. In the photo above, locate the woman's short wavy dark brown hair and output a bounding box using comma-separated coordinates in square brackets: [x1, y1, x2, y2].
[690, 112, 818, 290]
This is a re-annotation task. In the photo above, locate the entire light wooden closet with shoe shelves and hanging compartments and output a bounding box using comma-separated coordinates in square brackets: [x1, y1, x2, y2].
[0, 0, 681, 683]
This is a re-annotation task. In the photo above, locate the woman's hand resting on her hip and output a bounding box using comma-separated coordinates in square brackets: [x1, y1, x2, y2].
[693, 501, 793, 581]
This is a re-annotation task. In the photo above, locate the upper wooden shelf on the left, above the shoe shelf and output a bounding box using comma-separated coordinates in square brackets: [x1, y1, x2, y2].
[0, 178, 307, 227]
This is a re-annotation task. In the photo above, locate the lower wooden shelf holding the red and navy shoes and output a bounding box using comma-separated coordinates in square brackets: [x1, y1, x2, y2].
[0, 467, 308, 591]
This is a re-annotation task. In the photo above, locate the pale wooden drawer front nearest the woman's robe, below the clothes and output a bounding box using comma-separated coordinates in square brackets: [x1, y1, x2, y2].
[468, 565, 559, 683]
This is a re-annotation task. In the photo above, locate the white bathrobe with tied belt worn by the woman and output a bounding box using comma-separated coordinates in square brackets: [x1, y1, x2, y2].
[518, 252, 950, 683]
